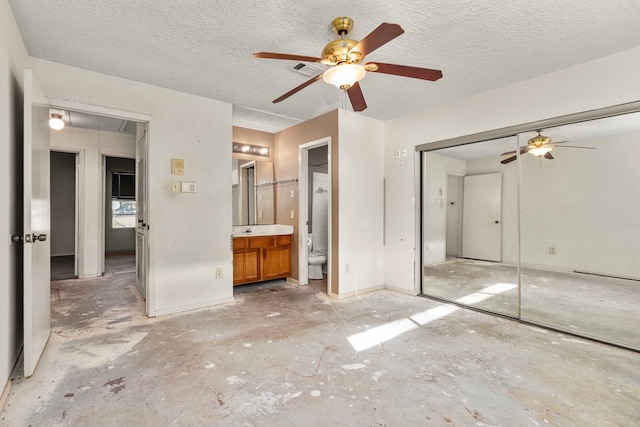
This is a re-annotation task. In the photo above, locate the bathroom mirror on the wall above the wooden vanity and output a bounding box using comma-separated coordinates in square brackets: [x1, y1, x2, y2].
[231, 159, 275, 225]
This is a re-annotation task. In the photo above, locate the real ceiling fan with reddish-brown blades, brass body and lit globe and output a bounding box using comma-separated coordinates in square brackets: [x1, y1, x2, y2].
[253, 16, 442, 111]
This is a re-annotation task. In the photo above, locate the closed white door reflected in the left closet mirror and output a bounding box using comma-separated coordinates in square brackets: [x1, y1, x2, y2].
[462, 173, 502, 261]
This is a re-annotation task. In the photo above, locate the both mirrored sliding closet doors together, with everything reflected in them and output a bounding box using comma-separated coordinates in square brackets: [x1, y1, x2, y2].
[421, 108, 640, 349]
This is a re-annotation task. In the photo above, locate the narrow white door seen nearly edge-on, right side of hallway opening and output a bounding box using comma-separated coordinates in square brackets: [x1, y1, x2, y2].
[136, 123, 149, 304]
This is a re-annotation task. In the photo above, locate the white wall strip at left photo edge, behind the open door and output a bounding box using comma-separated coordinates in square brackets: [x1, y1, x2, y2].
[0, 0, 27, 404]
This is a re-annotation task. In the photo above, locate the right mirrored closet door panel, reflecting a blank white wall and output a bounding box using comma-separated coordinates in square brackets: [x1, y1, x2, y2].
[513, 113, 640, 349]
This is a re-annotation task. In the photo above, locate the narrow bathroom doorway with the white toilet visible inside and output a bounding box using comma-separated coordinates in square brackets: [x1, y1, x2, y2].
[298, 138, 332, 294]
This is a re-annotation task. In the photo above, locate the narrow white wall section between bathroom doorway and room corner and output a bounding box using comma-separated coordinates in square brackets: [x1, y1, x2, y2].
[334, 111, 384, 297]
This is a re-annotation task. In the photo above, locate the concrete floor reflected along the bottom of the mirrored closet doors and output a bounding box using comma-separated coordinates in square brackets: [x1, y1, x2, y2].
[425, 258, 640, 349]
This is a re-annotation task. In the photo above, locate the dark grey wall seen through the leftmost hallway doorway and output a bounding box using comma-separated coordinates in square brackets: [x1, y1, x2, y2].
[51, 151, 76, 257]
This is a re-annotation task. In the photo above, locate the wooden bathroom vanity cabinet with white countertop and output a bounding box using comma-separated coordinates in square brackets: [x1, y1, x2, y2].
[232, 225, 293, 286]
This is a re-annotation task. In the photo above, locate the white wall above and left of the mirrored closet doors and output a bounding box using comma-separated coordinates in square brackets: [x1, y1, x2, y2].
[382, 48, 640, 292]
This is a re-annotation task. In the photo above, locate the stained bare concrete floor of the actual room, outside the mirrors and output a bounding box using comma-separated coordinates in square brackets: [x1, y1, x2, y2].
[0, 272, 640, 427]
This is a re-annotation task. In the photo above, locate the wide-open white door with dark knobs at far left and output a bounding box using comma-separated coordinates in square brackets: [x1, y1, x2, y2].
[22, 70, 51, 377]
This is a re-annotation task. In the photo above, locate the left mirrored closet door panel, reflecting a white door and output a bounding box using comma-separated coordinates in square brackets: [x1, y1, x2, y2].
[422, 136, 518, 317]
